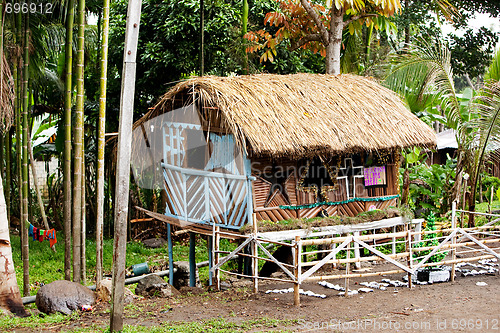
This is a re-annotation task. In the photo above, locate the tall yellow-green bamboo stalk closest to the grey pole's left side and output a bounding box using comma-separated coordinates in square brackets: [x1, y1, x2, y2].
[96, 0, 110, 290]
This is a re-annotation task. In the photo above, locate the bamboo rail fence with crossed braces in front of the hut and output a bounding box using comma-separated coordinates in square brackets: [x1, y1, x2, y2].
[211, 204, 500, 305]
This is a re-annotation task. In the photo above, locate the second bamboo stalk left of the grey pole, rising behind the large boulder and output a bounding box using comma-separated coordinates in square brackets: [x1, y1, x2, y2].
[73, 0, 85, 283]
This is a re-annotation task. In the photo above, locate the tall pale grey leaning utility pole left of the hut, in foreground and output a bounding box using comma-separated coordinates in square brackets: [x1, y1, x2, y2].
[110, 0, 141, 332]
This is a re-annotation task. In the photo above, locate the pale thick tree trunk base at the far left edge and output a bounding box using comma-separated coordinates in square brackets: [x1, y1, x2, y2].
[0, 172, 26, 316]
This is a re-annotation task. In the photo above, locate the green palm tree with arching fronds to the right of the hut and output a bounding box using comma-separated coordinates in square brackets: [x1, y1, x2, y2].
[385, 39, 500, 226]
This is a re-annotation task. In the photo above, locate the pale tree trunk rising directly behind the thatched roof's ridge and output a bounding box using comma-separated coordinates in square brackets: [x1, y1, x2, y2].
[325, 6, 344, 75]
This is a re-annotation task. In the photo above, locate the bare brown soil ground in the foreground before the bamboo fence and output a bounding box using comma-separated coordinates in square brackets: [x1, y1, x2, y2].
[16, 262, 500, 332]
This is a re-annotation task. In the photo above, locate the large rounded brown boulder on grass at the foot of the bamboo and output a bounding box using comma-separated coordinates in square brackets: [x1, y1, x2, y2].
[35, 280, 95, 315]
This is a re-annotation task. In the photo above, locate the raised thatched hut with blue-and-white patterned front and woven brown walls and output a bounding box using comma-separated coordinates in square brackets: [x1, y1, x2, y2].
[133, 74, 435, 294]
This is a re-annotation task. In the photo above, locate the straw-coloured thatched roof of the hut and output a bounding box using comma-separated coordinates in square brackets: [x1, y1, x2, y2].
[144, 74, 436, 157]
